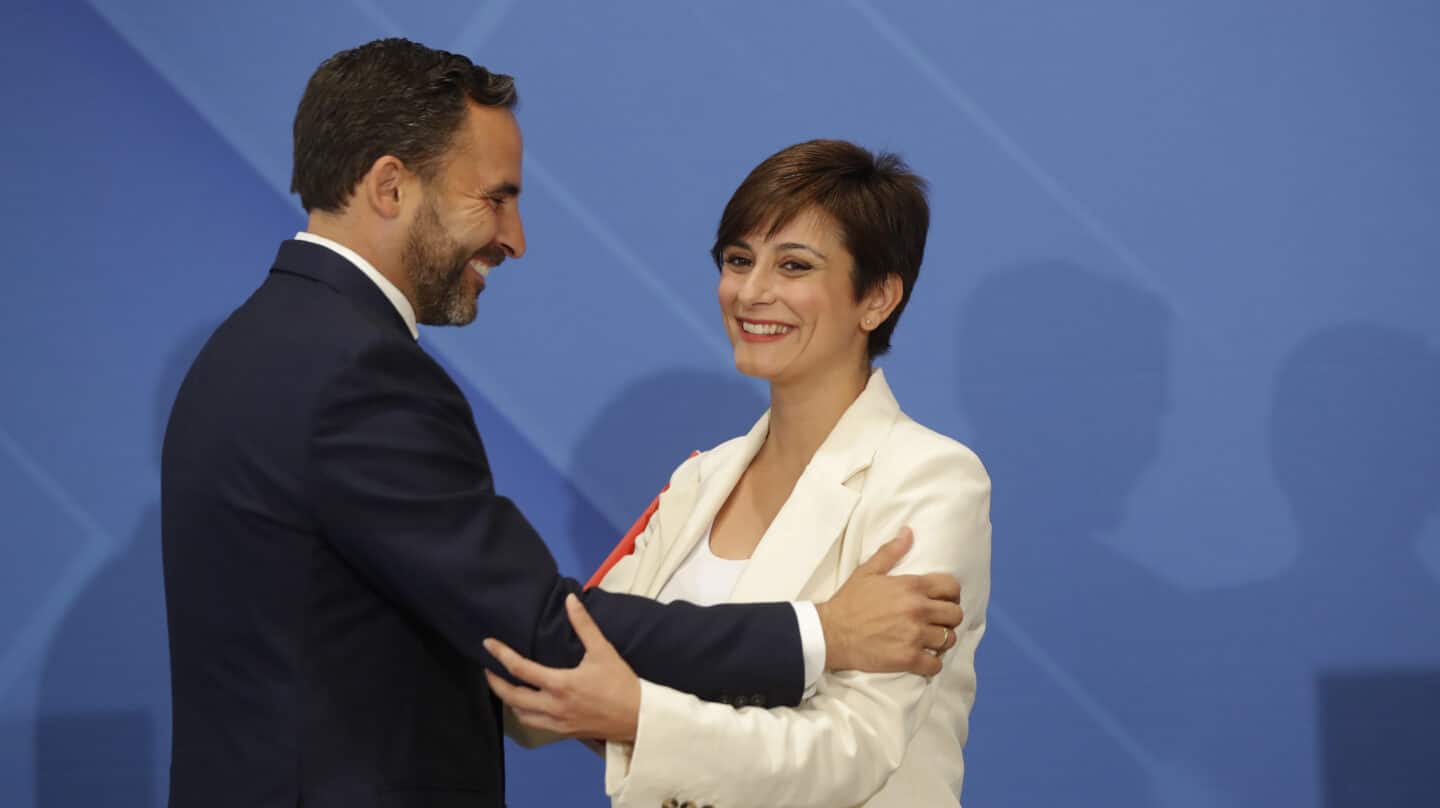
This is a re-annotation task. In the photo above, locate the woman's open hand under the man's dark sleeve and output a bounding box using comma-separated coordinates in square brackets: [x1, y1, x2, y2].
[485, 595, 639, 740]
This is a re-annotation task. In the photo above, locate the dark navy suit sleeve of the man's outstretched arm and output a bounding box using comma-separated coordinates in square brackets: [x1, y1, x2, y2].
[305, 340, 804, 704]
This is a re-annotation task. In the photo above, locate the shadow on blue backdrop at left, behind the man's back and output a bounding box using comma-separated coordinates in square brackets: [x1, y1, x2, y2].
[35, 327, 213, 808]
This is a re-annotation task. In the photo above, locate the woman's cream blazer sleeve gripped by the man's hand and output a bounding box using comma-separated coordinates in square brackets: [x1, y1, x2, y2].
[605, 444, 989, 808]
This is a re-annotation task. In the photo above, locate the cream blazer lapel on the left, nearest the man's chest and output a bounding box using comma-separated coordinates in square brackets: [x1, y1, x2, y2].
[634, 410, 770, 598]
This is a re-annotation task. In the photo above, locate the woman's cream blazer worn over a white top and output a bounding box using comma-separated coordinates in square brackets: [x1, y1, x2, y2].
[600, 372, 991, 808]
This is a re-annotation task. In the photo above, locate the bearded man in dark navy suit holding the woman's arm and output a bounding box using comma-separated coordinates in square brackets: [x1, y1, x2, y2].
[161, 40, 960, 808]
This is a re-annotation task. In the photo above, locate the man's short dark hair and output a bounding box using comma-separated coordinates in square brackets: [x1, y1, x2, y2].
[289, 39, 518, 213]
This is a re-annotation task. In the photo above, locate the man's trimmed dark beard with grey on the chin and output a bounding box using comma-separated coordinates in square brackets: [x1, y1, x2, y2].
[405, 203, 475, 326]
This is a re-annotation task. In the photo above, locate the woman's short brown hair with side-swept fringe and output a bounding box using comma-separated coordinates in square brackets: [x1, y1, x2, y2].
[710, 140, 930, 359]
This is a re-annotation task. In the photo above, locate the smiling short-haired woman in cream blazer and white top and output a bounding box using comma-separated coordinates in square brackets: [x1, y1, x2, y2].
[491, 141, 991, 808]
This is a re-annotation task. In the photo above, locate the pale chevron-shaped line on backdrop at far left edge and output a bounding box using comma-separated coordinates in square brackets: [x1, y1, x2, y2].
[0, 426, 120, 699]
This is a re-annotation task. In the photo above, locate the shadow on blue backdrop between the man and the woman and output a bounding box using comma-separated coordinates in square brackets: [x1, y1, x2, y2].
[570, 369, 769, 570]
